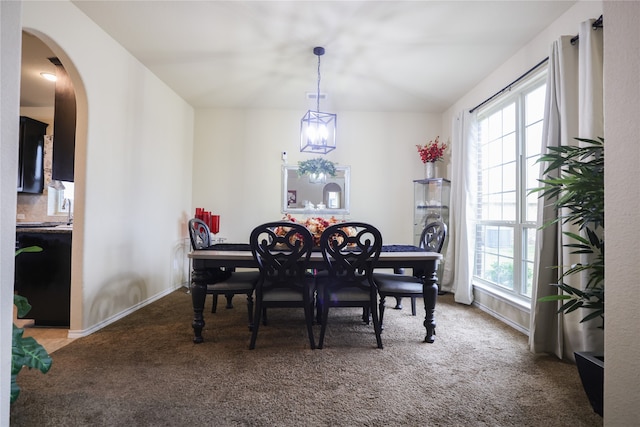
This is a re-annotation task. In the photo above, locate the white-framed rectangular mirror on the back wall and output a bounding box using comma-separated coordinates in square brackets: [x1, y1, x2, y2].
[282, 166, 351, 215]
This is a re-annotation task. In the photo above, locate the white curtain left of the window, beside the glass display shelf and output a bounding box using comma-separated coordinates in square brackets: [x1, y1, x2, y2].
[443, 108, 478, 304]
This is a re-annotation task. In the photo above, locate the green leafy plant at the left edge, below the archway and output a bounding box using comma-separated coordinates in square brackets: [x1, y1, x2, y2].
[10, 246, 52, 403]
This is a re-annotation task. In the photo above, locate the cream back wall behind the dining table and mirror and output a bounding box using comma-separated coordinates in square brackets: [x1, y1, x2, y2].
[193, 108, 440, 243]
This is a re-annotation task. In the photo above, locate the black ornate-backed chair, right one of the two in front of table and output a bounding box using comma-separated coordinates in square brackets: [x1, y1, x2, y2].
[316, 222, 382, 348]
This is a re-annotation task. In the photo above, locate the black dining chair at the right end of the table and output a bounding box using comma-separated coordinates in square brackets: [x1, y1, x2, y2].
[373, 221, 447, 325]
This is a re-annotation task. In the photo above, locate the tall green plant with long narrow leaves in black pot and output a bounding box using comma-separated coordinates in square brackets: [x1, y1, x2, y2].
[533, 138, 604, 415]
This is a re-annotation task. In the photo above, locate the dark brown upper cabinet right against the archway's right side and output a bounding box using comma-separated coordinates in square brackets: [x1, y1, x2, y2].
[49, 58, 76, 182]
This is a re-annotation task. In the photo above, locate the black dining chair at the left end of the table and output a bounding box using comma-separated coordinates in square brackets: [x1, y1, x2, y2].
[189, 218, 260, 329]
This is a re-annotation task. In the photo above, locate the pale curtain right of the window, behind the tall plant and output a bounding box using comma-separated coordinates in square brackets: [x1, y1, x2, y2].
[529, 20, 604, 360]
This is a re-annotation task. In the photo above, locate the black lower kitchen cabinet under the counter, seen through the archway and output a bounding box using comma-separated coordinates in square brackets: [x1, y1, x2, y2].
[14, 229, 72, 327]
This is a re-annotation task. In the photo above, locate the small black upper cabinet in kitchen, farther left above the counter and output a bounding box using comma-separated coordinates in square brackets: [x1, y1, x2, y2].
[18, 116, 48, 193]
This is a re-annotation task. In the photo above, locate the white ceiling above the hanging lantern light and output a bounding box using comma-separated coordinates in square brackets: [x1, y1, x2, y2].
[22, 0, 576, 113]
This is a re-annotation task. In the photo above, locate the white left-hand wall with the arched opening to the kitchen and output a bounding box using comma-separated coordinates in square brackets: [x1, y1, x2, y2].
[23, 1, 193, 336]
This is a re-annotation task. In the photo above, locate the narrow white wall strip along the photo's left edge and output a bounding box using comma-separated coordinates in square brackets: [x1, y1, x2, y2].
[0, 1, 22, 425]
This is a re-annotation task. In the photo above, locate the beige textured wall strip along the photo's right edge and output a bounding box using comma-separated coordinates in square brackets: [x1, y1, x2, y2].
[604, 1, 640, 426]
